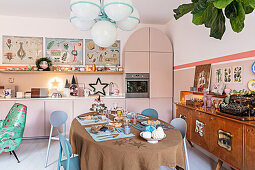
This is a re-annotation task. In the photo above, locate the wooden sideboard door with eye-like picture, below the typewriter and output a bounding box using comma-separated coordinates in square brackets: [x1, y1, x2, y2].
[209, 116, 243, 169]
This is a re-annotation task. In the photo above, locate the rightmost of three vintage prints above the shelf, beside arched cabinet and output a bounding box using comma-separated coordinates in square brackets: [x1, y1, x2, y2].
[85, 39, 120, 66]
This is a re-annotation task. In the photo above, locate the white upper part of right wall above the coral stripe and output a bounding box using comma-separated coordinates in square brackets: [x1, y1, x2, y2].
[166, 13, 255, 66]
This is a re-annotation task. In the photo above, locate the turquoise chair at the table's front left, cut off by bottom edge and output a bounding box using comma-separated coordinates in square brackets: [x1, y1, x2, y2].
[58, 131, 80, 170]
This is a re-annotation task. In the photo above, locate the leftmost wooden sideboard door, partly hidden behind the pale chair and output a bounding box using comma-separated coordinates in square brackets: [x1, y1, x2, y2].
[176, 105, 193, 140]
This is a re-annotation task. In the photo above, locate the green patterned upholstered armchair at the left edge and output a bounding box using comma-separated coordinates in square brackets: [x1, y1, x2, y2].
[0, 103, 27, 163]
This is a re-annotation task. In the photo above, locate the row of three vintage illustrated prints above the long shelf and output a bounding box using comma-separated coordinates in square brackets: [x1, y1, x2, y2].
[2, 36, 120, 66]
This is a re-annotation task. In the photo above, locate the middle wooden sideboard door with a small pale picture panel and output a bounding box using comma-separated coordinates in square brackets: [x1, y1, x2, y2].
[190, 111, 211, 150]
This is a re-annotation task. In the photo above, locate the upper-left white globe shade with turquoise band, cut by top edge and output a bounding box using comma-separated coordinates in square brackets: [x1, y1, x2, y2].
[70, 0, 101, 20]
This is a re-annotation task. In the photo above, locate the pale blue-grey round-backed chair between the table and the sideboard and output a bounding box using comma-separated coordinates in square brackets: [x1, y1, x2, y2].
[171, 118, 190, 170]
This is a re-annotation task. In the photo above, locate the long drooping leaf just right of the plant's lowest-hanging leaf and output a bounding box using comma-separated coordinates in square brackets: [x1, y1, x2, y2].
[230, 1, 245, 33]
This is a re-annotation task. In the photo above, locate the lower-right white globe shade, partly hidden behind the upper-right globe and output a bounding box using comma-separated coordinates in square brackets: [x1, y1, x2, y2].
[117, 8, 140, 31]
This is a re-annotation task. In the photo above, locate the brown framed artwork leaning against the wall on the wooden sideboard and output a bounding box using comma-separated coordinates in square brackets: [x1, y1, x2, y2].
[194, 64, 211, 89]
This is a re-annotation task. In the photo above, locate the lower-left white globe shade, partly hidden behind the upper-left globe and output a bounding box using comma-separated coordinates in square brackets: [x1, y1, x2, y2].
[70, 13, 95, 31]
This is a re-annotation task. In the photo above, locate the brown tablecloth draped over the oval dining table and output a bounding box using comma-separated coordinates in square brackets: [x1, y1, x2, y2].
[69, 112, 186, 170]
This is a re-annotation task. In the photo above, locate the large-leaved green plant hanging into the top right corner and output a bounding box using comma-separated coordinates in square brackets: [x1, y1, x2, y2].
[173, 0, 255, 39]
